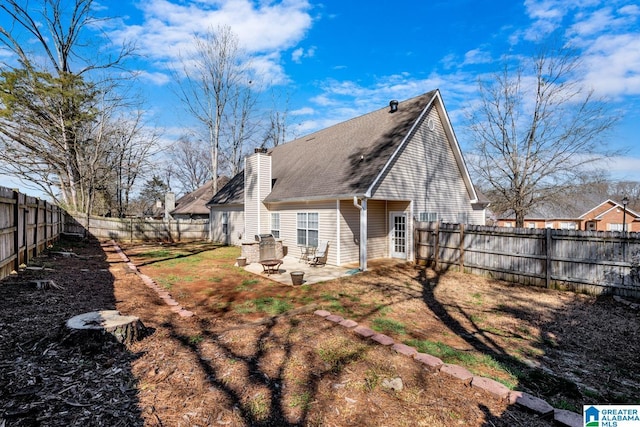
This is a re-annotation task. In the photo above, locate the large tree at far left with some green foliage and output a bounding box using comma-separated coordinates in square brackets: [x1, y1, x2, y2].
[0, 0, 132, 211]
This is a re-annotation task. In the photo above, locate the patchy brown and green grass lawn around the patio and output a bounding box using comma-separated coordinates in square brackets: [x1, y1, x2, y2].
[112, 243, 640, 425]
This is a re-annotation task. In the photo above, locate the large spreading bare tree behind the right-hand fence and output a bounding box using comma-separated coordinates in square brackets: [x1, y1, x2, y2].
[467, 42, 616, 227]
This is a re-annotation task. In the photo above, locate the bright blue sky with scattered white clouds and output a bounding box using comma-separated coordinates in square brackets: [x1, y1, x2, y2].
[0, 0, 640, 194]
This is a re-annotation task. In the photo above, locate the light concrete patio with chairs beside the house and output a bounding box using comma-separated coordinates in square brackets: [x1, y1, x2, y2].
[244, 256, 360, 286]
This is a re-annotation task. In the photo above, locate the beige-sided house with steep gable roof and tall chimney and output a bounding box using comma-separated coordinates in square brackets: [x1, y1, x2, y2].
[208, 90, 487, 270]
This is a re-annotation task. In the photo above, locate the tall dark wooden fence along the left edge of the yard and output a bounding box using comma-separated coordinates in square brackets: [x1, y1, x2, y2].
[0, 187, 64, 279]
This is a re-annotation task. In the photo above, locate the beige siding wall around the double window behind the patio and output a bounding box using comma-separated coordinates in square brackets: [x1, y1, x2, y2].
[269, 200, 338, 265]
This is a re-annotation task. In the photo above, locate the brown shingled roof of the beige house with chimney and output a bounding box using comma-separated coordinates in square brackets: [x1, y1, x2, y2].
[209, 90, 437, 205]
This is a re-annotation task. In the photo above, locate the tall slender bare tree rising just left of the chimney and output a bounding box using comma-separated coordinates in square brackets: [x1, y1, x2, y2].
[178, 26, 251, 193]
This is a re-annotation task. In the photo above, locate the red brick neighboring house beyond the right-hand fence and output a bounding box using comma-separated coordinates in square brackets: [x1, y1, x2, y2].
[497, 199, 640, 232]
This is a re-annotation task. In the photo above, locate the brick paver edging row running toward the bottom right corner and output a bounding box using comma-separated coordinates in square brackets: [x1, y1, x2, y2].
[313, 310, 583, 427]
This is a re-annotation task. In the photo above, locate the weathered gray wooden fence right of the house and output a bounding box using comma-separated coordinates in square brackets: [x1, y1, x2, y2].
[415, 222, 640, 298]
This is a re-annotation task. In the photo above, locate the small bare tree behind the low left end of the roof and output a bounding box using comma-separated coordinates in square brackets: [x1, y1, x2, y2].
[168, 136, 211, 193]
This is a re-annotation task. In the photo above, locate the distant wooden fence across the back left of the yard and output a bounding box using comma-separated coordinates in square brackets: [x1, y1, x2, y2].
[64, 212, 209, 242]
